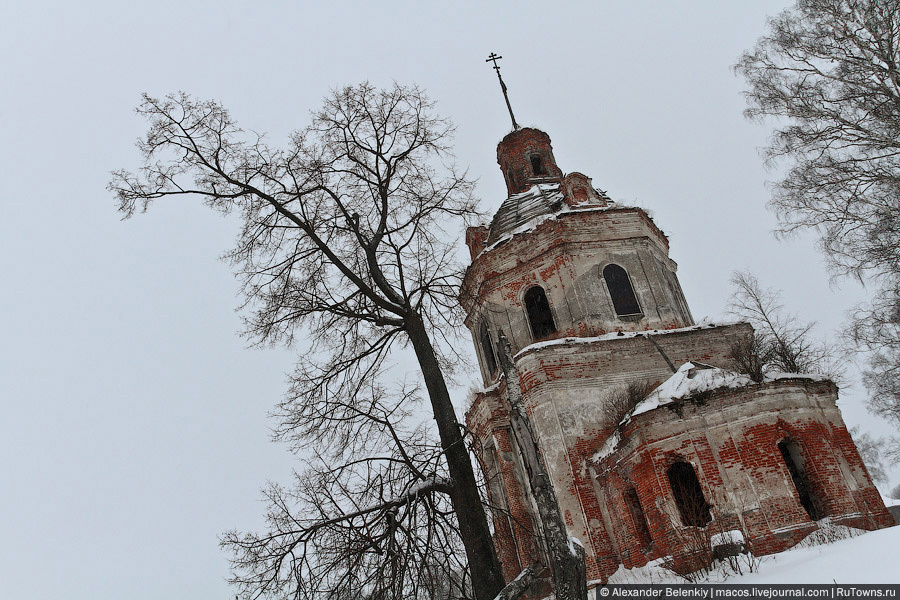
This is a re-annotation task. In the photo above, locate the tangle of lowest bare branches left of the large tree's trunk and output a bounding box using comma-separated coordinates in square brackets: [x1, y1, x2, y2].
[222, 386, 472, 600]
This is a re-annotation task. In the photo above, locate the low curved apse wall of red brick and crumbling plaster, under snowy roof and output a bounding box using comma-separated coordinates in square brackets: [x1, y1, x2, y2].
[590, 378, 892, 576]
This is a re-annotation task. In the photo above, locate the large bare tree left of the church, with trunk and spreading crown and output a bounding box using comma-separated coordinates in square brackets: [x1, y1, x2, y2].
[109, 84, 503, 600]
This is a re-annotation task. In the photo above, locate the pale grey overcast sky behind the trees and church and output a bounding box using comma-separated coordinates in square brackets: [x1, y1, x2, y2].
[0, 1, 897, 600]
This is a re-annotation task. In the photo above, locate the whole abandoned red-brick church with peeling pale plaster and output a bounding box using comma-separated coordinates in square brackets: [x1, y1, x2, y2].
[461, 128, 894, 582]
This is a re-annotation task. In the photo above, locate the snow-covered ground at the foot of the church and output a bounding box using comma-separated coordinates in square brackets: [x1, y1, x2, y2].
[609, 498, 900, 584]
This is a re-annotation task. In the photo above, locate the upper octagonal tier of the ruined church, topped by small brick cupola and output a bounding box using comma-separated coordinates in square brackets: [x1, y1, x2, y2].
[460, 127, 693, 383]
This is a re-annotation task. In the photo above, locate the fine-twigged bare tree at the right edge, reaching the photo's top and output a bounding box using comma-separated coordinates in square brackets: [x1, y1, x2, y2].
[735, 0, 900, 426]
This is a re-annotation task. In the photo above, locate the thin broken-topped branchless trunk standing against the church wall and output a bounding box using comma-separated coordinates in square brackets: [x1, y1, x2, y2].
[498, 331, 587, 600]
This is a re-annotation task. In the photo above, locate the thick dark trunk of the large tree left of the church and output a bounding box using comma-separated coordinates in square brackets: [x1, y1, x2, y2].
[406, 315, 504, 600]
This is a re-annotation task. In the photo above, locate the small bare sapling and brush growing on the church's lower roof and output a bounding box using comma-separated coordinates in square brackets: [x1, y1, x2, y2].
[729, 272, 843, 383]
